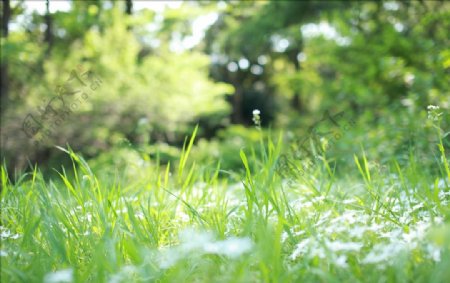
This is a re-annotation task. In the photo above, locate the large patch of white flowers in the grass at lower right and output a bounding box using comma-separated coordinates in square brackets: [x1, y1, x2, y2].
[282, 179, 450, 269]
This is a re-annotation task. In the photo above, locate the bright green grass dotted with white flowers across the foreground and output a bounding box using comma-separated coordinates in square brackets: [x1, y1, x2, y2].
[0, 118, 450, 282]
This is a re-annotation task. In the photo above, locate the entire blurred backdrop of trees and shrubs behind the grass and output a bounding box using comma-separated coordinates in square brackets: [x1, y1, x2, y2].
[1, 0, 450, 178]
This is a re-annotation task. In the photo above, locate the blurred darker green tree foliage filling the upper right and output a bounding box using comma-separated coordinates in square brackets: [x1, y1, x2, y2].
[205, 1, 449, 123]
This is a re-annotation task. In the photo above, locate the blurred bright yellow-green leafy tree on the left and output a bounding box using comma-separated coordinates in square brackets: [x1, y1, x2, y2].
[2, 1, 232, 172]
